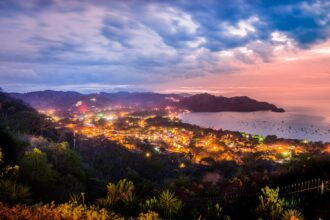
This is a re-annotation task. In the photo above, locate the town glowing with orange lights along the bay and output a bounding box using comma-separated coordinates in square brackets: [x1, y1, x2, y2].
[42, 101, 326, 168]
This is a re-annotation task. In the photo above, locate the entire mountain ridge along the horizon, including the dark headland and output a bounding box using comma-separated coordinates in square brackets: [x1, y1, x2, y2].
[11, 90, 284, 112]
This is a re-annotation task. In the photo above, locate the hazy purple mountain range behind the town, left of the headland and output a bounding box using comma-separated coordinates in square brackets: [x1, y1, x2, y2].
[11, 90, 183, 110]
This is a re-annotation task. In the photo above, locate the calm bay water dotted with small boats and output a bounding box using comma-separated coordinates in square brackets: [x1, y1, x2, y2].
[179, 111, 330, 142]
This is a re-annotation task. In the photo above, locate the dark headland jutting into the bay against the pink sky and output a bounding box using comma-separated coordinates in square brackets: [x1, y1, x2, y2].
[179, 93, 284, 112]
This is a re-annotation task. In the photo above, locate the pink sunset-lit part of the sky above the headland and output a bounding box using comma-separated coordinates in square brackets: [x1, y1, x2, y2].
[157, 41, 330, 115]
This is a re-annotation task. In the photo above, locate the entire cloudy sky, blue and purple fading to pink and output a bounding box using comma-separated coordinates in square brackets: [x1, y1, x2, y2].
[0, 0, 330, 113]
